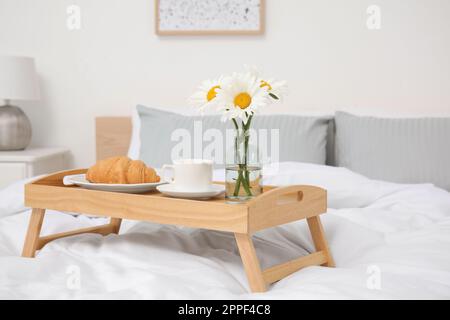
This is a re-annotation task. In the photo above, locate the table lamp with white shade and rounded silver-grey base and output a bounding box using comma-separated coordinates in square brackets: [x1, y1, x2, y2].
[0, 55, 39, 151]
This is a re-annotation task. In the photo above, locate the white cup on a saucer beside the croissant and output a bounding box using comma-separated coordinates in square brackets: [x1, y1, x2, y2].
[162, 159, 213, 192]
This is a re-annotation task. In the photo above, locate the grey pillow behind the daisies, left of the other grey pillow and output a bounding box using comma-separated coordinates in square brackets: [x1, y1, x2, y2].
[137, 106, 330, 167]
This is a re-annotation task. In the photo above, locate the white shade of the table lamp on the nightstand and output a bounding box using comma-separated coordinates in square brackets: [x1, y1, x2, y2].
[0, 55, 39, 100]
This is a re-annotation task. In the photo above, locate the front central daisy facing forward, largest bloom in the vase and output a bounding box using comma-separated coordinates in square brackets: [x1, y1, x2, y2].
[216, 72, 268, 124]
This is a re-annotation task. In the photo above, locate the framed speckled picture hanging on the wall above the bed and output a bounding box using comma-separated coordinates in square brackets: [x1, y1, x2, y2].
[155, 0, 265, 35]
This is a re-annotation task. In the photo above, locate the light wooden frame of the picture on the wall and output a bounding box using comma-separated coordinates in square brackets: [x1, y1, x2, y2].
[155, 0, 266, 36]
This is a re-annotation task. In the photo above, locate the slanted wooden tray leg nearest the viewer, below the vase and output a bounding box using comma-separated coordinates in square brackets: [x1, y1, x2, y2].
[234, 233, 267, 292]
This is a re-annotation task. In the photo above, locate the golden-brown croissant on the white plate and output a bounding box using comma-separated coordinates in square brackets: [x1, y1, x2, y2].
[86, 157, 160, 184]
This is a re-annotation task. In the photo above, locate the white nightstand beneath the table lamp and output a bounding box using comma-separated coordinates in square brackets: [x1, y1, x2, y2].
[0, 148, 69, 188]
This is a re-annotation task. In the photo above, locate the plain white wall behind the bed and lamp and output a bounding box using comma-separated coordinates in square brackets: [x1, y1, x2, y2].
[0, 0, 450, 166]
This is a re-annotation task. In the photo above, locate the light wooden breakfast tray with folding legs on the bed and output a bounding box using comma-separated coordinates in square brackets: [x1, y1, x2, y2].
[22, 169, 334, 292]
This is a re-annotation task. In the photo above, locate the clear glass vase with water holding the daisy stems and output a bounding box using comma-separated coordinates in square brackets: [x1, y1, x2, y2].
[225, 129, 262, 203]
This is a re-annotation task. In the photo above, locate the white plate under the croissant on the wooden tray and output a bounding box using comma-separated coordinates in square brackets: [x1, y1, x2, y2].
[63, 174, 166, 193]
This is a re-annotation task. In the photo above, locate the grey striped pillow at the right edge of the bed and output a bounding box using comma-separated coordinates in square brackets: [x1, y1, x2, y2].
[335, 112, 450, 190]
